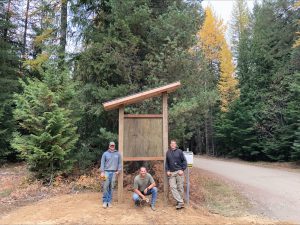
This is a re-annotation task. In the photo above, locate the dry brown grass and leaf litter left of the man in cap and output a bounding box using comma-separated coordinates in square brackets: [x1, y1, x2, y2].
[0, 163, 101, 215]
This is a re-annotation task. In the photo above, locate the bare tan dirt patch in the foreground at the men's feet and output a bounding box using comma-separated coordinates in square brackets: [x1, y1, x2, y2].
[0, 192, 275, 224]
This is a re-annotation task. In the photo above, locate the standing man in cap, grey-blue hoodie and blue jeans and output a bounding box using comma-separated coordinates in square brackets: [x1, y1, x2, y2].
[100, 142, 122, 208]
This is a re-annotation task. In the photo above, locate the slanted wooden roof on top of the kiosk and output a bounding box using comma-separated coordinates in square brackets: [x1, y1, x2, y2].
[103, 81, 181, 110]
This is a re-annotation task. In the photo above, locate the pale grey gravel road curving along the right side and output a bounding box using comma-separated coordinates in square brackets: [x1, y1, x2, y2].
[193, 157, 300, 224]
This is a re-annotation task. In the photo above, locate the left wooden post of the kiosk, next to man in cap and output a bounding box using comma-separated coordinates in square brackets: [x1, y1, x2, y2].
[118, 105, 124, 203]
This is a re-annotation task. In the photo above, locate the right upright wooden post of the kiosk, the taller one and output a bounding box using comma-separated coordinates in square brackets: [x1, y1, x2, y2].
[162, 92, 169, 206]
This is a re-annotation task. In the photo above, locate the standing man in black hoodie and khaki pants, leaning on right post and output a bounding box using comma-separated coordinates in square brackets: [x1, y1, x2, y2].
[165, 140, 187, 209]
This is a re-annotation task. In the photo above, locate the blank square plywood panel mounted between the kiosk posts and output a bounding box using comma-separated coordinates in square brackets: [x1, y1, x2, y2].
[123, 118, 164, 158]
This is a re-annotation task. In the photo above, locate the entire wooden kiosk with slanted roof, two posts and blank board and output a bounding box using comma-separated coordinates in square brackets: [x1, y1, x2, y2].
[103, 81, 181, 203]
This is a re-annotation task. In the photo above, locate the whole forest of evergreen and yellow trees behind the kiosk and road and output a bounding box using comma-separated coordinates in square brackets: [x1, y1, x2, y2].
[0, 0, 300, 181]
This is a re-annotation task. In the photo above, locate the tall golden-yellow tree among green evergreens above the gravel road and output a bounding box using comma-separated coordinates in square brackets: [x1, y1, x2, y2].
[197, 7, 239, 112]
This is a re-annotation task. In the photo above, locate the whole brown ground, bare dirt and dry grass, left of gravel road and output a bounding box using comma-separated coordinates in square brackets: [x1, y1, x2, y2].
[0, 164, 290, 224]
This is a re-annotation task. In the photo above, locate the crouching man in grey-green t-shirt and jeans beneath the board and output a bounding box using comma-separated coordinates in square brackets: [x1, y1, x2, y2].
[132, 167, 157, 211]
